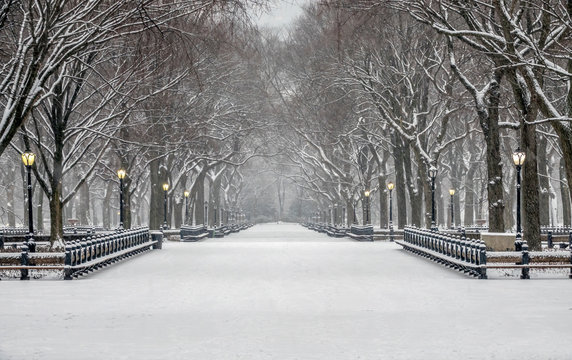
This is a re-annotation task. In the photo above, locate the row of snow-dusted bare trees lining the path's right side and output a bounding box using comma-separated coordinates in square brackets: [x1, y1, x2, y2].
[268, 0, 572, 248]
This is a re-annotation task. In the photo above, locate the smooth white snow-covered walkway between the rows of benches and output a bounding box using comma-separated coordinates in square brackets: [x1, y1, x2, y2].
[0, 224, 572, 360]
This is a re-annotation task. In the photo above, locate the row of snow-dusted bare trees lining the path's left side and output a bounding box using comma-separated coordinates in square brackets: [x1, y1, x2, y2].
[0, 0, 274, 244]
